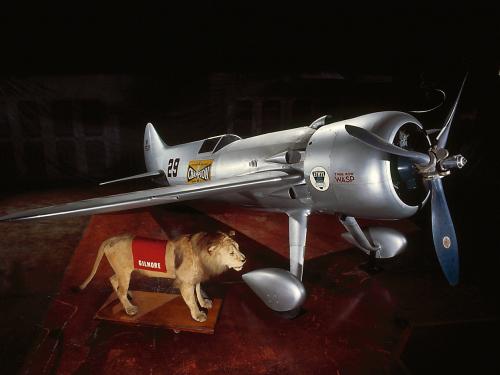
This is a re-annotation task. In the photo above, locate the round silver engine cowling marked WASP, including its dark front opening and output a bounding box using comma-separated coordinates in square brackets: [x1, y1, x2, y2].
[304, 112, 430, 219]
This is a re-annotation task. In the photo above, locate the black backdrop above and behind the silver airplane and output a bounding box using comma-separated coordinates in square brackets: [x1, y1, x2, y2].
[0, 2, 500, 374]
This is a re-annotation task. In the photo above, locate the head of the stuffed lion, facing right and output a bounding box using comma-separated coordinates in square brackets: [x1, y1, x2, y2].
[208, 231, 246, 271]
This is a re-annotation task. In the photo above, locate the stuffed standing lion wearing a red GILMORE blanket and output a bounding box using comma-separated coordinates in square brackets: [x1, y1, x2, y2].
[79, 231, 246, 322]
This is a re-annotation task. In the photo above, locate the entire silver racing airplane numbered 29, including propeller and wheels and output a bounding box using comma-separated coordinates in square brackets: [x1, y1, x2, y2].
[0, 76, 467, 312]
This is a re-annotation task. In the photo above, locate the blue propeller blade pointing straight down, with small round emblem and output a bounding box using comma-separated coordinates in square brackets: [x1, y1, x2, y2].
[431, 178, 459, 285]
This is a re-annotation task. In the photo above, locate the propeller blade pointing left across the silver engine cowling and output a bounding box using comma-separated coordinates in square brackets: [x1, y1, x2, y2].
[345, 125, 430, 165]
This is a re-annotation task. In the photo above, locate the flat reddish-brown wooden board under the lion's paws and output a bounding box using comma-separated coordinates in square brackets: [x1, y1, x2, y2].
[95, 290, 222, 334]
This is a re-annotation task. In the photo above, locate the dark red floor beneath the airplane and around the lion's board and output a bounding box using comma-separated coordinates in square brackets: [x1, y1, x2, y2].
[7, 206, 500, 374]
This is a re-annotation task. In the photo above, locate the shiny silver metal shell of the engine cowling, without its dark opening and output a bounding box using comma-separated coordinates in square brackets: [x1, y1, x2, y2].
[304, 112, 430, 219]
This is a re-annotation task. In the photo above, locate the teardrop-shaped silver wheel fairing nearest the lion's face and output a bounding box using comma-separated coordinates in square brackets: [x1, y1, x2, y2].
[243, 268, 306, 312]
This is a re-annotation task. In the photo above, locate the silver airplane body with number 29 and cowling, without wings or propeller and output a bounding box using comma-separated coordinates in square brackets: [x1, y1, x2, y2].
[145, 112, 428, 219]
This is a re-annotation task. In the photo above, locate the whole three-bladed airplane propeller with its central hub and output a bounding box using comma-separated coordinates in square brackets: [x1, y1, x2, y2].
[345, 74, 468, 285]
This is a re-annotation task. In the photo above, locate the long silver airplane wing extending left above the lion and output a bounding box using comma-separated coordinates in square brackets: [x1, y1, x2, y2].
[0, 171, 303, 221]
